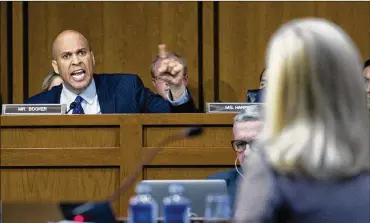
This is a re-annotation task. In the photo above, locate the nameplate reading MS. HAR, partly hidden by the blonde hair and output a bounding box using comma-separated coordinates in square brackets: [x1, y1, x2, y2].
[206, 102, 262, 113]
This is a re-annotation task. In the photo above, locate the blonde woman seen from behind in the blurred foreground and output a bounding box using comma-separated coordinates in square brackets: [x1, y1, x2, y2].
[235, 19, 370, 223]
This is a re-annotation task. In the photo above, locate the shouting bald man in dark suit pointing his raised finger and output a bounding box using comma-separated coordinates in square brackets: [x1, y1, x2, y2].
[25, 30, 196, 114]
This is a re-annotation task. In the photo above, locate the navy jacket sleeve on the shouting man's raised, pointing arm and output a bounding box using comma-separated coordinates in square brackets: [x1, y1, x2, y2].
[135, 75, 197, 113]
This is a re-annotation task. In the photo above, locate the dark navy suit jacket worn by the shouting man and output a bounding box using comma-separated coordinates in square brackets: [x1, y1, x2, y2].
[25, 74, 196, 114]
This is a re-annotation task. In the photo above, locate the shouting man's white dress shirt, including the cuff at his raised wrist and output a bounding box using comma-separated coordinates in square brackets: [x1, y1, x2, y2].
[60, 79, 189, 115]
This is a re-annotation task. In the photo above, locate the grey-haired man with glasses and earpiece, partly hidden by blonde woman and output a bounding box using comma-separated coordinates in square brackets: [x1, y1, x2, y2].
[207, 105, 262, 213]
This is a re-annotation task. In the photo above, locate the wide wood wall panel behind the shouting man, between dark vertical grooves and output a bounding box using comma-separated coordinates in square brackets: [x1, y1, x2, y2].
[28, 2, 199, 106]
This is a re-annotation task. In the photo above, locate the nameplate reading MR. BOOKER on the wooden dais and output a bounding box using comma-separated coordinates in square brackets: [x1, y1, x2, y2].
[2, 104, 67, 115]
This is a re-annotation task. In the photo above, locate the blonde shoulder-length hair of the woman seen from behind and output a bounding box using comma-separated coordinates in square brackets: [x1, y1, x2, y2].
[261, 18, 370, 179]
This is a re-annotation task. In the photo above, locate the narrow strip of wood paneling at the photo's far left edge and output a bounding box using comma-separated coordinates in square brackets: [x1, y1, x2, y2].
[0, 2, 9, 103]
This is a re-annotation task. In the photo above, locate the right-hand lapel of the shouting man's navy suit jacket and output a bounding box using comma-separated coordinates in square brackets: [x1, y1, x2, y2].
[94, 74, 116, 114]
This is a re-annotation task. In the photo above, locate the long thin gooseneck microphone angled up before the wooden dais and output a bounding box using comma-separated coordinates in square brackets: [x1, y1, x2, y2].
[73, 127, 203, 218]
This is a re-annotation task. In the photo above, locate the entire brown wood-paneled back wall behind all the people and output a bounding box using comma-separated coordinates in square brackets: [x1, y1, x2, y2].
[1, 2, 370, 105]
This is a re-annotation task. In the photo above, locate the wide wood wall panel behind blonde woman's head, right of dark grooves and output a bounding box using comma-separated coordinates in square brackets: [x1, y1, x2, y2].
[219, 2, 370, 102]
